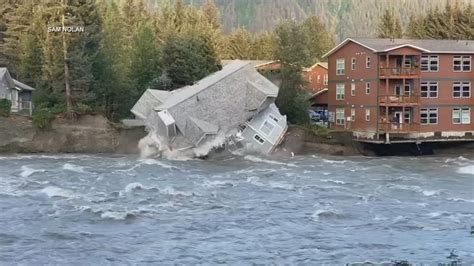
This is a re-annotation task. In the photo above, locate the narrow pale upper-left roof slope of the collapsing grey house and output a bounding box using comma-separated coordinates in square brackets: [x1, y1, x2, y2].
[155, 60, 249, 110]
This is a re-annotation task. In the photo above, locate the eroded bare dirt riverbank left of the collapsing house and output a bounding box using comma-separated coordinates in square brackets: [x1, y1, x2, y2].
[0, 115, 146, 154]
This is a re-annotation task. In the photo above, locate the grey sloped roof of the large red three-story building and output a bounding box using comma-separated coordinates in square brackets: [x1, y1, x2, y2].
[323, 38, 474, 57]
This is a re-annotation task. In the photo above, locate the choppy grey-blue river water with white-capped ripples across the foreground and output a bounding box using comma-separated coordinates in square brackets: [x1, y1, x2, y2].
[0, 155, 474, 265]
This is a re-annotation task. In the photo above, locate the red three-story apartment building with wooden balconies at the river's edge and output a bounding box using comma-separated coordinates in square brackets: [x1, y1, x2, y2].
[325, 38, 474, 143]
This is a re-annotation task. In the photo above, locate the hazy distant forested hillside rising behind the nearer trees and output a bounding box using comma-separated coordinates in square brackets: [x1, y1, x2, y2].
[150, 0, 474, 40]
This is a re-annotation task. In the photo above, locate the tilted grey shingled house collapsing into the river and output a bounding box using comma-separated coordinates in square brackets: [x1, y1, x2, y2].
[131, 60, 287, 157]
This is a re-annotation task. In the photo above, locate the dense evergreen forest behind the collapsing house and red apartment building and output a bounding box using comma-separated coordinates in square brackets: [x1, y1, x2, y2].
[0, 0, 474, 126]
